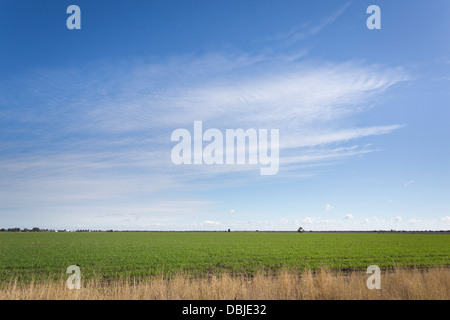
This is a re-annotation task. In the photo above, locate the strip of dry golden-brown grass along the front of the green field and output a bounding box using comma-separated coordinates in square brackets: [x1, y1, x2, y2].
[0, 268, 450, 300]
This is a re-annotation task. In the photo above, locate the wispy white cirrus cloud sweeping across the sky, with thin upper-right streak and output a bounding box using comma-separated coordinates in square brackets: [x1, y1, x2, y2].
[0, 11, 411, 229]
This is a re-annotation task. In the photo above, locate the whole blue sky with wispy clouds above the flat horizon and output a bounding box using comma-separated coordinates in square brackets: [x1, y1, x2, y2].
[0, 0, 450, 230]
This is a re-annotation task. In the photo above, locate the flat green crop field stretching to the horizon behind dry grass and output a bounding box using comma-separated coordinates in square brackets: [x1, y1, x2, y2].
[0, 232, 450, 283]
